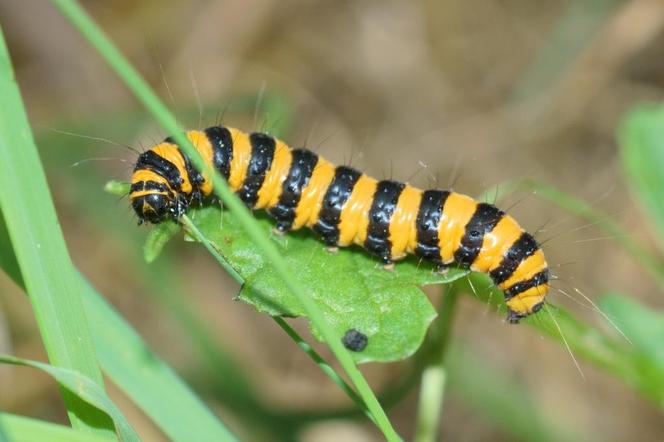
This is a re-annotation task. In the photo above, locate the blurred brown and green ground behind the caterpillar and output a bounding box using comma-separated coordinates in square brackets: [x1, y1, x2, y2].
[0, 0, 664, 441]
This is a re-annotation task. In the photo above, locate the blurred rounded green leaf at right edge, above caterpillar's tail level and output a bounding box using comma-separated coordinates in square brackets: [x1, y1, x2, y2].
[618, 105, 664, 245]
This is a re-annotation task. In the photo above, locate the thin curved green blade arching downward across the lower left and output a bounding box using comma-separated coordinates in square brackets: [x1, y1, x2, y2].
[0, 353, 140, 442]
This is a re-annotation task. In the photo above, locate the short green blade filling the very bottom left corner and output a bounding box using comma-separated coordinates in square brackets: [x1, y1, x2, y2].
[0, 413, 115, 442]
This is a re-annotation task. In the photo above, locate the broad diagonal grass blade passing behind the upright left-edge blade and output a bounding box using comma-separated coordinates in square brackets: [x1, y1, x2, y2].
[0, 212, 237, 441]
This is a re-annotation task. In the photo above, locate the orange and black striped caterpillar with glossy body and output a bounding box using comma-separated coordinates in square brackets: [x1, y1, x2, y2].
[129, 126, 549, 323]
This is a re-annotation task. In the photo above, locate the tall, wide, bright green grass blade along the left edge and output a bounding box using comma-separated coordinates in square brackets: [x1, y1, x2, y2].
[0, 23, 112, 434]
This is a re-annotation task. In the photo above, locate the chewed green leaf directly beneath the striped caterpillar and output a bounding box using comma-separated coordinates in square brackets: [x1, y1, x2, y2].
[184, 207, 467, 362]
